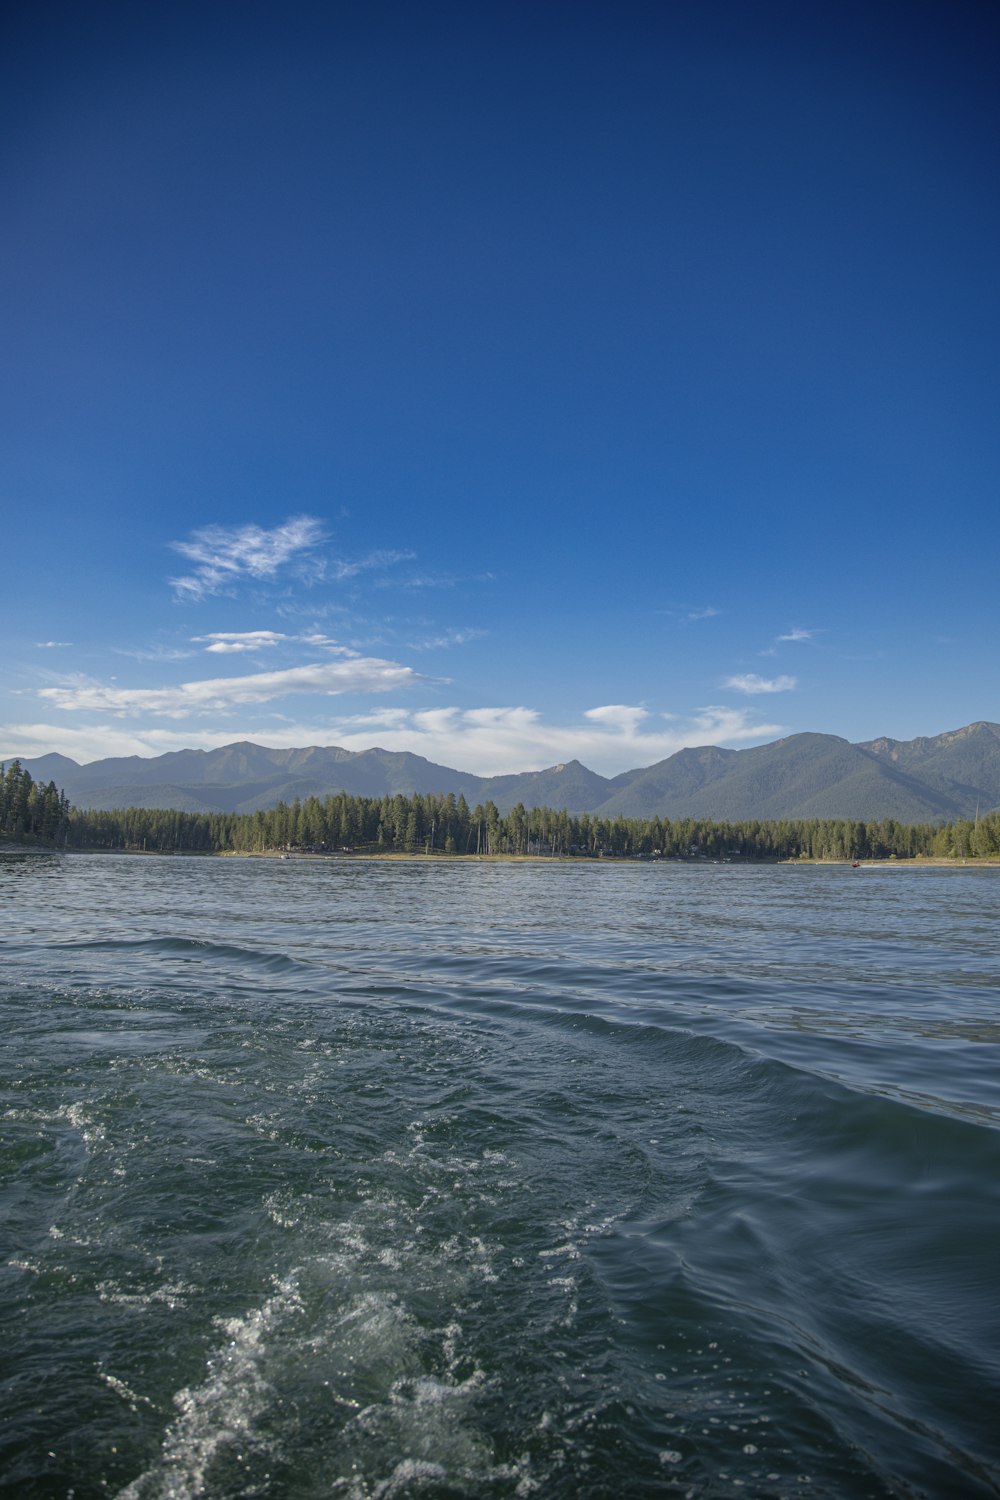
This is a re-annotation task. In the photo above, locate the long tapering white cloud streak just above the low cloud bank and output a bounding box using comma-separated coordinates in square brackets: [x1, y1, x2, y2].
[39, 657, 429, 719]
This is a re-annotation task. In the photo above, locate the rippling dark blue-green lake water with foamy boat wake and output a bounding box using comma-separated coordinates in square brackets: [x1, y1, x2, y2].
[0, 855, 1000, 1500]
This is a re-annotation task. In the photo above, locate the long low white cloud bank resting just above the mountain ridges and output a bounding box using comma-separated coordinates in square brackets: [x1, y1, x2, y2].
[0, 704, 787, 776]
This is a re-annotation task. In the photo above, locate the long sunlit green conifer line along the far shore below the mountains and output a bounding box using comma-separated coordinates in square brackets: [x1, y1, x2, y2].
[60, 792, 1000, 861]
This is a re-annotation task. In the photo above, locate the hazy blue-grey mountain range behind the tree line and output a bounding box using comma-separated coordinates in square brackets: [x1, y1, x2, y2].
[6, 722, 1000, 822]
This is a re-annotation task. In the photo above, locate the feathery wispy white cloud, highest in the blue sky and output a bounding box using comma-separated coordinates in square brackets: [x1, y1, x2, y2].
[169, 516, 325, 602]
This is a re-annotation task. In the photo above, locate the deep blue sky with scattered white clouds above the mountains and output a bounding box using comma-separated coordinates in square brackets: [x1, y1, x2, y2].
[0, 0, 1000, 774]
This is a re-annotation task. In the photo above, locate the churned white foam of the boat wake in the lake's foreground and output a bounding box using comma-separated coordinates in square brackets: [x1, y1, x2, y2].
[115, 1115, 539, 1500]
